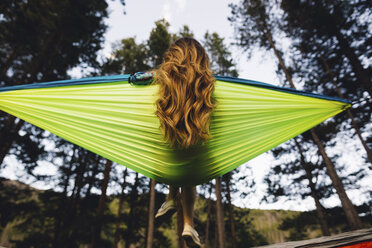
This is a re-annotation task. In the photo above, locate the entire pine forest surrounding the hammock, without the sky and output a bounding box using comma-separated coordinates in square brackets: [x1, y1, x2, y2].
[0, 0, 372, 248]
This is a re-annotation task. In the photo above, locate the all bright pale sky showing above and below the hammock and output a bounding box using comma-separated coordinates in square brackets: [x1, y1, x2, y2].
[0, 0, 372, 210]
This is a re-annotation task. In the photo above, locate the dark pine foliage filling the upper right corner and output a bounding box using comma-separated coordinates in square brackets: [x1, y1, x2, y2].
[281, 0, 372, 99]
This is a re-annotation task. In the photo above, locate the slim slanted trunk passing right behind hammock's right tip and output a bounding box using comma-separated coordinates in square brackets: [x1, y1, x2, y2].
[320, 55, 372, 163]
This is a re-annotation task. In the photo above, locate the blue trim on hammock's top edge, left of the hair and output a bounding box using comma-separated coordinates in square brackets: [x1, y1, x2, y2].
[0, 74, 130, 92]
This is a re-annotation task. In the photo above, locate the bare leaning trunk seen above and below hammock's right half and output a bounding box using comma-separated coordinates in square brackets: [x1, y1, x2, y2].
[266, 30, 363, 230]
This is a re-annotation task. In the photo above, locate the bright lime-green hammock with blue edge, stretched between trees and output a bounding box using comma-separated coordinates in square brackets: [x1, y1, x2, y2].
[0, 75, 350, 186]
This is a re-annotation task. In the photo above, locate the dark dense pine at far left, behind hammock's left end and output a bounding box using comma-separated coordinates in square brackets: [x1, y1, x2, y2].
[0, 0, 112, 172]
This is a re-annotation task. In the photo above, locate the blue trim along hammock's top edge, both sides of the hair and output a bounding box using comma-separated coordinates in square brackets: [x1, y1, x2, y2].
[0, 74, 351, 104]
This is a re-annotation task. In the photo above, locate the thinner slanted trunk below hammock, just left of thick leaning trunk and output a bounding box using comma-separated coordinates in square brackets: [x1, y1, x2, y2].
[294, 138, 331, 236]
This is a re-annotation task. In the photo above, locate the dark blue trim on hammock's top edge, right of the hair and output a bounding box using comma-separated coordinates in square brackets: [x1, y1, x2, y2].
[214, 75, 351, 104]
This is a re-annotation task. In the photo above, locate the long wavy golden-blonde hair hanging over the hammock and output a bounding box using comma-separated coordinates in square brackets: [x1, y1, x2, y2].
[154, 38, 216, 148]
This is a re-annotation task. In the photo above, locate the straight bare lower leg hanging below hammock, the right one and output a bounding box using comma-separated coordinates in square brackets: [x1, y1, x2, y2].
[181, 187, 196, 227]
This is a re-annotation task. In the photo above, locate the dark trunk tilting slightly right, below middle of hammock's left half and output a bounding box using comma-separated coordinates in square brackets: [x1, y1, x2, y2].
[91, 160, 112, 248]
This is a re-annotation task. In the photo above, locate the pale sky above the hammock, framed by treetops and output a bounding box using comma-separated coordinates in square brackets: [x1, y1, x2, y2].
[99, 0, 278, 84]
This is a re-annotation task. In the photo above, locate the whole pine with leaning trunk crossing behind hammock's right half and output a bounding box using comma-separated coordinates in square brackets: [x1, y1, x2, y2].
[230, 0, 362, 229]
